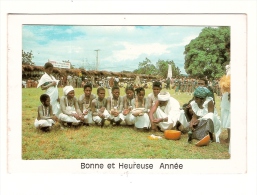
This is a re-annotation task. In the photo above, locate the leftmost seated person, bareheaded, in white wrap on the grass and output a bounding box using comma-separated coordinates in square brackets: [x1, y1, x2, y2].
[34, 94, 58, 132]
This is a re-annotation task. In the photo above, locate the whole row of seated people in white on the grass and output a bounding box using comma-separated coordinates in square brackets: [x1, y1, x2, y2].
[35, 81, 221, 142]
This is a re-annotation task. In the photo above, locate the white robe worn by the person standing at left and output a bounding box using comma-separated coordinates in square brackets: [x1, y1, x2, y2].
[37, 73, 60, 116]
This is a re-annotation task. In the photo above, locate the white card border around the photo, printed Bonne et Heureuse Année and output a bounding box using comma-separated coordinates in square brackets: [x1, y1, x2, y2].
[7, 14, 246, 173]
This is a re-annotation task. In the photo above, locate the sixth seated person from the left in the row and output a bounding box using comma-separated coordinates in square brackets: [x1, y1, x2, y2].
[122, 86, 135, 125]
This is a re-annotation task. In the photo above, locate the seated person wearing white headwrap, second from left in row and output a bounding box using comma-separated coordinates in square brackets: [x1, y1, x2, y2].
[59, 86, 84, 127]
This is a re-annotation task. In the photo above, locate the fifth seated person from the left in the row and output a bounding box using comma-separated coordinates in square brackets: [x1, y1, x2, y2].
[107, 86, 124, 125]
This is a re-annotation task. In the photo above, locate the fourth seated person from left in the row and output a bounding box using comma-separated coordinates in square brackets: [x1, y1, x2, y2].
[91, 87, 110, 127]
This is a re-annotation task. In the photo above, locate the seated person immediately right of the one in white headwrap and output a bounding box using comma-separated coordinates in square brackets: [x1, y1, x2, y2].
[78, 84, 96, 126]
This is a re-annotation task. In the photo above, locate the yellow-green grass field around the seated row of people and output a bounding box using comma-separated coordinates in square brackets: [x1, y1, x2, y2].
[22, 88, 230, 160]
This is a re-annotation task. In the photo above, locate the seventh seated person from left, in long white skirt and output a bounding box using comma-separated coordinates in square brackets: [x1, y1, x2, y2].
[132, 87, 151, 129]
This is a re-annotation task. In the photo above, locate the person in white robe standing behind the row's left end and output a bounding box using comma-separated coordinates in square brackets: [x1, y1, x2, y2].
[37, 62, 60, 117]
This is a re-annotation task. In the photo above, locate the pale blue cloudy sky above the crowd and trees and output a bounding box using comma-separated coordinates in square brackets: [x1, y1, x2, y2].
[22, 25, 204, 74]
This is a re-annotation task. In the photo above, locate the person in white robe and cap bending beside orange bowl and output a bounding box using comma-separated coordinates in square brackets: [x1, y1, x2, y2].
[149, 92, 180, 131]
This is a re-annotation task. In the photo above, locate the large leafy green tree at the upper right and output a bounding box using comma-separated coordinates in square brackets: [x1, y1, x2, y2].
[184, 27, 230, 78]
